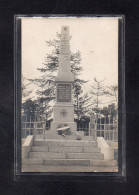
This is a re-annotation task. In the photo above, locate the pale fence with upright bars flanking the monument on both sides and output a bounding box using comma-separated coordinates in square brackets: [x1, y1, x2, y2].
[22, 113, 118, 141]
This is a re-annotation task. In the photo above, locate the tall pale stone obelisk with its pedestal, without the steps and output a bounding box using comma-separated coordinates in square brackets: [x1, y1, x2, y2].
[51, 26, 77, 133]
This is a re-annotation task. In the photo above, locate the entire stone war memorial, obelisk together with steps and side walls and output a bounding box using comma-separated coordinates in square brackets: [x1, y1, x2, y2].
[22, 26, 117, 172]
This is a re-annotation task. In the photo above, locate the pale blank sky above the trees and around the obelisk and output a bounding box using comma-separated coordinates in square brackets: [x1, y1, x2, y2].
[22, 17, 118, 101]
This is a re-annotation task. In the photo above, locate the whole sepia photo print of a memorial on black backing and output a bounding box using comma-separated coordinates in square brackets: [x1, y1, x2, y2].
[21, 16, 119, 173]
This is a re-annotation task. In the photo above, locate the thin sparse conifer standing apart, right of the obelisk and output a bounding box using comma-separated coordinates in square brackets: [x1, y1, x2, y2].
[90, 78, 105, 115]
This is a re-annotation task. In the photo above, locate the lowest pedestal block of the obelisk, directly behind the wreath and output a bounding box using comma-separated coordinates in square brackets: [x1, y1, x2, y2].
[51, 122, 77, 134]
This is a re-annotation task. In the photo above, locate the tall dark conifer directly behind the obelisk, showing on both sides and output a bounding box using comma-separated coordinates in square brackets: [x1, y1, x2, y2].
[29, 33, 87, 117]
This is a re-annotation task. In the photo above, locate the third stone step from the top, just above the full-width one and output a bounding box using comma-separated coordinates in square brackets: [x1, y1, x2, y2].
[29, 152, 104, 160]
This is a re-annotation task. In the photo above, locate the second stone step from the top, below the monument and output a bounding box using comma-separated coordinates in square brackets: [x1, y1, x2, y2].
[31, 146, 101, 153]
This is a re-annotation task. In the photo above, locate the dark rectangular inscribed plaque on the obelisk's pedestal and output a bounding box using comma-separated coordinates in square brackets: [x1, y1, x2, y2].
[57, 84, 71, 102]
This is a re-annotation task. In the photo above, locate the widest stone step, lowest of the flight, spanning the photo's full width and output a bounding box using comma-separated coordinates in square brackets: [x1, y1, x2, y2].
[22, 158, 117, 167]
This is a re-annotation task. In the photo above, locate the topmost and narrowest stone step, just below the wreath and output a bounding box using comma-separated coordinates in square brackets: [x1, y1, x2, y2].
[34, 139, 97, 147]
